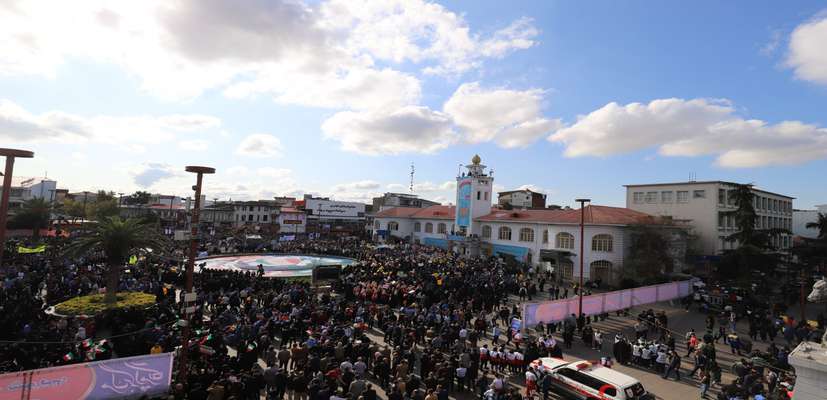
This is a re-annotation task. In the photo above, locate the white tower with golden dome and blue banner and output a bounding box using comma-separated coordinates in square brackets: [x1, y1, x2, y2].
[454, 155, 494, 235]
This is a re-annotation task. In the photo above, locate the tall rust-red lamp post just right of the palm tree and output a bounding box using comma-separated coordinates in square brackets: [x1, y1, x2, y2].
[178, 165, 215, 384]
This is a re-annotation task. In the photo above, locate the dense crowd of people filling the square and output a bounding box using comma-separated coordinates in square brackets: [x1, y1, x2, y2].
[0, 234, 808, 400]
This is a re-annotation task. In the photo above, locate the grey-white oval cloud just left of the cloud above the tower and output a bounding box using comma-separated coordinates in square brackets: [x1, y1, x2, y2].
[322, 106, 456, 155]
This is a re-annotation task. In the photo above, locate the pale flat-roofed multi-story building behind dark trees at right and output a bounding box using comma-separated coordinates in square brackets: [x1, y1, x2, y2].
[625, 181, 795, 255]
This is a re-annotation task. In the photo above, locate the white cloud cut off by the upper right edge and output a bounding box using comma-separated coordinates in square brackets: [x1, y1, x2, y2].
[786, 13, 827, 85]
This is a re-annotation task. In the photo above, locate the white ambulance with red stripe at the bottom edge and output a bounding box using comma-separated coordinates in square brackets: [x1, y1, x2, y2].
[531, 357, 655, 400]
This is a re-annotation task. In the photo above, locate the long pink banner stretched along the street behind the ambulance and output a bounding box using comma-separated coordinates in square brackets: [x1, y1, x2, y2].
[523, 281, 692, 327]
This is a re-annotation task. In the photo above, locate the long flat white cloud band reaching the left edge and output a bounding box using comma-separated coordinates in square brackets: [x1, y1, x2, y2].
[0, 99, 221, 144]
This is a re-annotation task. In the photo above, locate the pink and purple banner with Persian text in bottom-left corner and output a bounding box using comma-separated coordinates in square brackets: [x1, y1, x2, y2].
[0, 353, 172, 400]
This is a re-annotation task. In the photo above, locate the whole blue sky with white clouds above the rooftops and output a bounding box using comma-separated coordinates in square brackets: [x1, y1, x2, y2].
[0, 0, 827, 208]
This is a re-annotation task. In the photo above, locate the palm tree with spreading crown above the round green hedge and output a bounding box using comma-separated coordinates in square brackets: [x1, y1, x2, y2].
[66, 217, 167, 303]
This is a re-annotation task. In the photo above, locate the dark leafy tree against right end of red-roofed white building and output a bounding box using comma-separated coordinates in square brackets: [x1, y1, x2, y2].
[624, 225, 675, 282]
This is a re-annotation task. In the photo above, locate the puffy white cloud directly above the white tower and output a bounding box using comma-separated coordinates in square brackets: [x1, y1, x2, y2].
[444, 82, 560, 148]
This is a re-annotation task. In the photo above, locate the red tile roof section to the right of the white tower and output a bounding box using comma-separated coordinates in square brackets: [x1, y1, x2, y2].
[477, 206, 656, 225]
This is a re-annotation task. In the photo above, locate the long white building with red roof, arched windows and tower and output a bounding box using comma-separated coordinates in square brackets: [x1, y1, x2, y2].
[373, 156, 682, 283]
